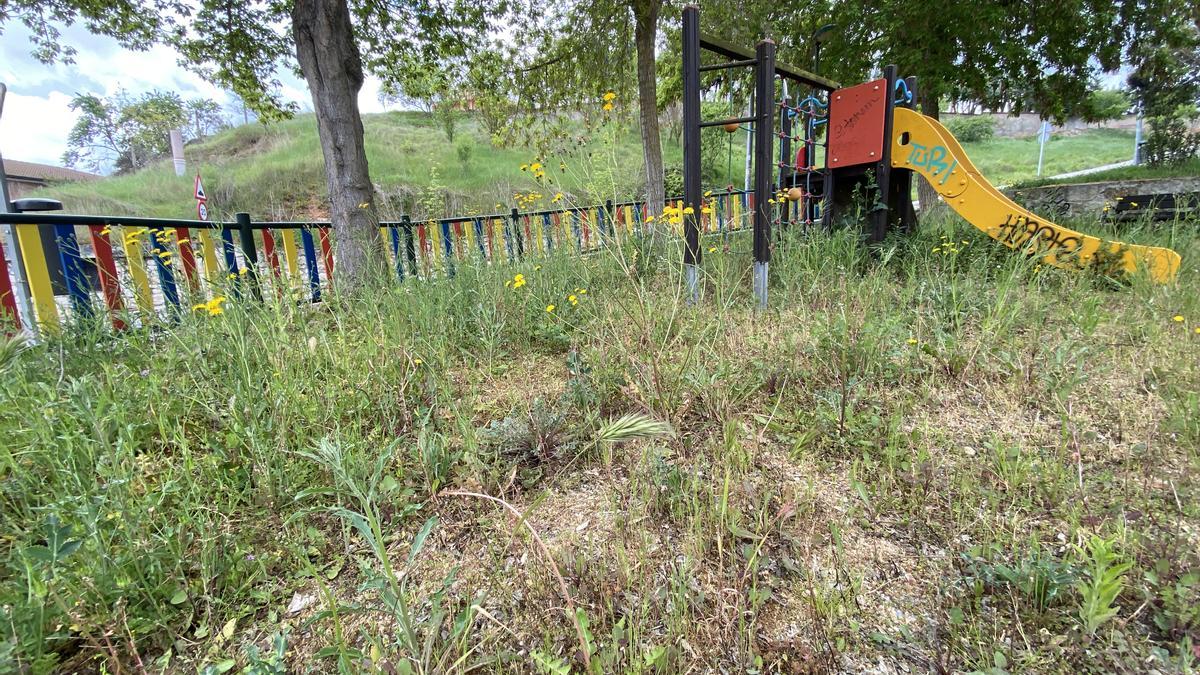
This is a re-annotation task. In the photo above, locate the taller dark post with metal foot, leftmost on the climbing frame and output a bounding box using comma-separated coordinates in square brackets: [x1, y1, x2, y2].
[683, 5, 703, 303]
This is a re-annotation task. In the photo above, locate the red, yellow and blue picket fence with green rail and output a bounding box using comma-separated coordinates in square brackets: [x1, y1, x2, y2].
[0, 191, 755, 333]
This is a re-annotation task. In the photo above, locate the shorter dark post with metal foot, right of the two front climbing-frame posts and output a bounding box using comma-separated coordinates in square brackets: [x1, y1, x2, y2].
[754, 40, 775, 309]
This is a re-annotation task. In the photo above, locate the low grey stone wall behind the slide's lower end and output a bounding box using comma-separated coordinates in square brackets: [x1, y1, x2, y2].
[1004, 175, 1200, 217]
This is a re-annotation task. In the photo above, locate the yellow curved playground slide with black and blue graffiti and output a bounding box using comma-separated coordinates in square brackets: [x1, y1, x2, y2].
[892, 108, 1180, 283]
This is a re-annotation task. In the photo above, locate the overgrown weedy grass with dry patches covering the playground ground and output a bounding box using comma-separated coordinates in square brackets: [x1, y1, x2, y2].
[0, 208, 1200, 673]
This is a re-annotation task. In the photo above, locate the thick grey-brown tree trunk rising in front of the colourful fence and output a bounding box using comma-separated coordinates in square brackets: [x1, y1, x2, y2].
[292, 0, 386, 292]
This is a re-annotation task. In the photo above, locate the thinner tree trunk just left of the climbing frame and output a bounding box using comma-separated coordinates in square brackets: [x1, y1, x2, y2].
[632, 0, 666, 214]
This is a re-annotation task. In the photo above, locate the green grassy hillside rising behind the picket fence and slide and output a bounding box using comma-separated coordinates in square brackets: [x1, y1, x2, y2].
[39, 112, 1133, 219]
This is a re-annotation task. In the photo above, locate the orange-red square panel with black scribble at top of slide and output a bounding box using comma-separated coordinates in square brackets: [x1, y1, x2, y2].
[829, 79, 888, 168]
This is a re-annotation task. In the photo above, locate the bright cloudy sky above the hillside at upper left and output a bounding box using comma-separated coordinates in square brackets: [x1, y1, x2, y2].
[0, 22, 384, 170]
